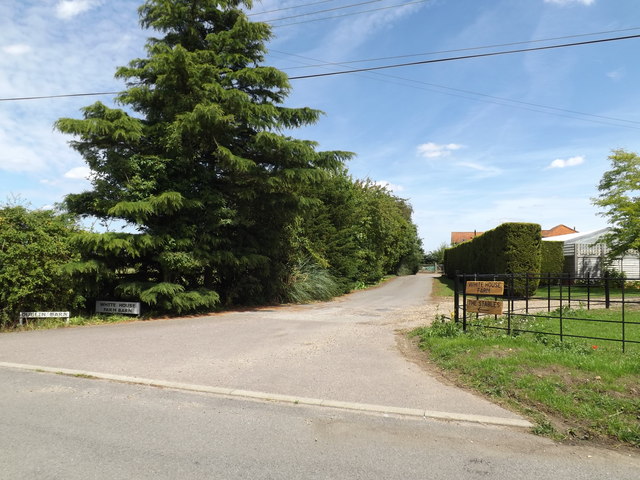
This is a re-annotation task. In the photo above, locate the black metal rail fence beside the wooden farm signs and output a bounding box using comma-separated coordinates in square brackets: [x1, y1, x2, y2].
[454, 274, 640, 352]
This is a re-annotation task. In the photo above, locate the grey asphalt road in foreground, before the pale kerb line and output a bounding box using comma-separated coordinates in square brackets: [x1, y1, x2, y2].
[0, 369, 640, 480]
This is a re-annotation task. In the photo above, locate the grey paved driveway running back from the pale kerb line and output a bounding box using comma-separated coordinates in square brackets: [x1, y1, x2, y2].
[0, 274, 520, 419]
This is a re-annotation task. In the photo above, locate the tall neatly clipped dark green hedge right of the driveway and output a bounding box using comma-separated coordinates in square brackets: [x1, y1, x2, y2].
[444, 223, 542, 296]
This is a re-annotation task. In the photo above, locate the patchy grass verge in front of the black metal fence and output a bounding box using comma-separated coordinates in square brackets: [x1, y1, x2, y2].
[412, 320, 640, 448]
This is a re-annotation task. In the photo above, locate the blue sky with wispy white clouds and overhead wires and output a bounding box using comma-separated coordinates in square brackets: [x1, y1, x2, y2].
[0, 0, 640, 251]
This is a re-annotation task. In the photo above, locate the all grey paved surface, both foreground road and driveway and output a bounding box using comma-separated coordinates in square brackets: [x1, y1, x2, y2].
[0, 275, 640, 480]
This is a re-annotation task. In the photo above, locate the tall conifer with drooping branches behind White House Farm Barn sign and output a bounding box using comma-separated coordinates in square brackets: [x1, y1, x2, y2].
[56, 0, 348, 312]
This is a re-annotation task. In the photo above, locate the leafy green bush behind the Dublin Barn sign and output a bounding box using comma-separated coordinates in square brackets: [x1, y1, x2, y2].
[0, 205, 83, 327]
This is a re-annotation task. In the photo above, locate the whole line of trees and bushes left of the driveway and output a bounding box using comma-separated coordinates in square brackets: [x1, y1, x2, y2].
[0, 0, 422, 322]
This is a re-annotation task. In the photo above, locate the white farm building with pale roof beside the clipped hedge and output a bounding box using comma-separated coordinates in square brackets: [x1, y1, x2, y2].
[543, 228, 640, 278]
